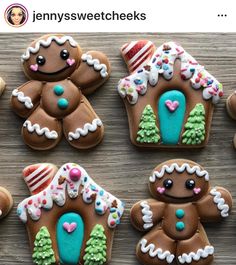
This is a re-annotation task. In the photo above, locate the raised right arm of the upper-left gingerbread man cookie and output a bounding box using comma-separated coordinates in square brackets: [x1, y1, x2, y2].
[71, 51, 111, 95]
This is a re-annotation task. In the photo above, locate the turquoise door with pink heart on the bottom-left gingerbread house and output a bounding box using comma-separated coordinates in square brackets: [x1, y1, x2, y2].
[57, 212, 84, 265]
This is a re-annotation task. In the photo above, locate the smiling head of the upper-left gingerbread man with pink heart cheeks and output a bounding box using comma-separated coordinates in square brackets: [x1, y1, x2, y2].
[22, 35, 81, 81]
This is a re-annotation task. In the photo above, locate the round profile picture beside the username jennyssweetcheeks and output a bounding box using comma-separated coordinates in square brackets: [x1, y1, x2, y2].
[5, 3, 29, 28]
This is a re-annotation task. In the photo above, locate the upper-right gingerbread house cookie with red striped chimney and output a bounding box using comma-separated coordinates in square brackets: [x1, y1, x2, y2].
[118, 40, 223, 148]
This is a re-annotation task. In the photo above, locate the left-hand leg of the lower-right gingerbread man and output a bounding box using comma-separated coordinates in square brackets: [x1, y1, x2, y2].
[136, 228, 176, 265]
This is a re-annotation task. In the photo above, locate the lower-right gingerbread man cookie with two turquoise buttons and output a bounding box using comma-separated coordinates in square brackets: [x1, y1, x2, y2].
[131, 159, 232, 265]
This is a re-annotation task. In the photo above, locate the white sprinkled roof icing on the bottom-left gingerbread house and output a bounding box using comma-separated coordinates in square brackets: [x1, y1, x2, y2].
[17, 163, 124, 228]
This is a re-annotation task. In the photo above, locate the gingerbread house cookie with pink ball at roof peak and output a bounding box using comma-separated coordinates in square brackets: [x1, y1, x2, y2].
[17, 163, 124, 265]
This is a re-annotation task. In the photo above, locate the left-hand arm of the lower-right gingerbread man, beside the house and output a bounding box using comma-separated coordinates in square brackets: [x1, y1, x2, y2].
[130, 199, 165, 231]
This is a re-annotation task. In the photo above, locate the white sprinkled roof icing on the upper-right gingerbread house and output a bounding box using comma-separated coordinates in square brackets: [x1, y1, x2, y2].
[118, 42, 223, 104]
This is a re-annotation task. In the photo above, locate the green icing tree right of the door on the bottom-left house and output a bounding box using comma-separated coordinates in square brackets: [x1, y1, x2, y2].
[83, 224, 107, 265]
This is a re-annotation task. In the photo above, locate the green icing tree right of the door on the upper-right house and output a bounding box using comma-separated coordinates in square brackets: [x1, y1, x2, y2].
[182, 103, 205, 145]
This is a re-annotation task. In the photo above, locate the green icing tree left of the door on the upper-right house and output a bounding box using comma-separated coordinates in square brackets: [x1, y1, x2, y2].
[136, 105, 160, 144]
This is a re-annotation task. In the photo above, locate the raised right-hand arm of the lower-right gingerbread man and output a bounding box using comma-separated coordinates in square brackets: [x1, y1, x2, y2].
[196, 187, 232, 222]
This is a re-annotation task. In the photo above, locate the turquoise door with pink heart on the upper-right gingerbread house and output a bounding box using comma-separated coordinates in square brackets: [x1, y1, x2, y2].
[158, 90, 186, 145]
